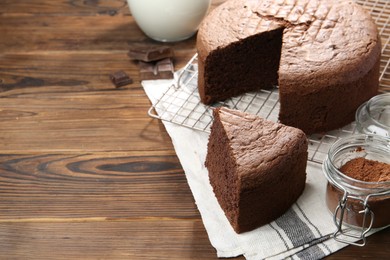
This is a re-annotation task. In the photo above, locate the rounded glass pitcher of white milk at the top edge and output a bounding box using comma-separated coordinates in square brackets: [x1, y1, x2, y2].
[127, 0, 211, 42]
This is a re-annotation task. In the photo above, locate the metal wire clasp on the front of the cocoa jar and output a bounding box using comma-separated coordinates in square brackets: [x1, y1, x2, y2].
[333, 190, 379, 246]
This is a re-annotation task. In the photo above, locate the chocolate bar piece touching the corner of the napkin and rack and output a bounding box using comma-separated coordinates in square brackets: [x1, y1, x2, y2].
[139, 58, 174, 80]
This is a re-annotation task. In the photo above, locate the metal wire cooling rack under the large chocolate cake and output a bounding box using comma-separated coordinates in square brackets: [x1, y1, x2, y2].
[148, 0, 390, 163]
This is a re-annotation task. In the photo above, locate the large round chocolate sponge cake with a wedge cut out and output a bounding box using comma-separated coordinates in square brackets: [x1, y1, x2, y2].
[197, 0, 381, 134]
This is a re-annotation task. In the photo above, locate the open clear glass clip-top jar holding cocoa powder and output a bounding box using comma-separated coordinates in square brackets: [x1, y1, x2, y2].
[323, 134, 390, 246]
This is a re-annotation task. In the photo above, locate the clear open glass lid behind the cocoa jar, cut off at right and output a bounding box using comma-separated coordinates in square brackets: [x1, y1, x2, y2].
[355, 93, 390, 136]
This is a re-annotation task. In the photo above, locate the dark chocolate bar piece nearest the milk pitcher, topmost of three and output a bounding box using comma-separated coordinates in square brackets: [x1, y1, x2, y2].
[127, 46, 173, 62]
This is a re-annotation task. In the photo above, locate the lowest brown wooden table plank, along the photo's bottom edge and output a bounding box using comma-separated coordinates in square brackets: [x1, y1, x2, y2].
[0, 219, 225, 260]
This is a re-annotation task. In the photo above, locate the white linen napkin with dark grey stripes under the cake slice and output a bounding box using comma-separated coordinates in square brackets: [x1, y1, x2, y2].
[142, 73, 380, 259]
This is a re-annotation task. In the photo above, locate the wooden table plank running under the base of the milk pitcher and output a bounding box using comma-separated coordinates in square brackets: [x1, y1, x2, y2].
[0, 12, 200, 55]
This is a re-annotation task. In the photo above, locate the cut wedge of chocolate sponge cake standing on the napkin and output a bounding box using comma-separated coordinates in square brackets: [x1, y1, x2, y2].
[205, 108, 308, 233]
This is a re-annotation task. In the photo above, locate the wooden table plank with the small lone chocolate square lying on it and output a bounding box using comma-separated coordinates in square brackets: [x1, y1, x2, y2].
[0, 51, 196, 93]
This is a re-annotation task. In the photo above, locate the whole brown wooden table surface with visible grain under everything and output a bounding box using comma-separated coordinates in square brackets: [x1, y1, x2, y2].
[0, 0, 390, 259]
